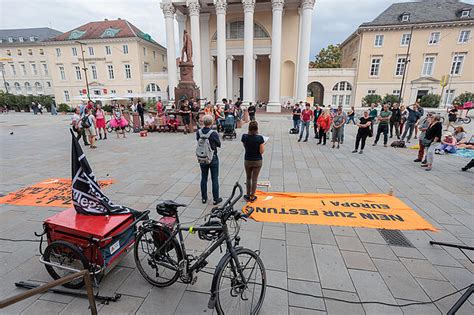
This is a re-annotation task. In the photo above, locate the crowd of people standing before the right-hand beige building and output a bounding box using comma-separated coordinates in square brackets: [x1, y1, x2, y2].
[290, 102, 474, 171]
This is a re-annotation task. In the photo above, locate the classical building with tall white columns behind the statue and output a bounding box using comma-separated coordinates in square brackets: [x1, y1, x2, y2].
[161, 0, 315, 112]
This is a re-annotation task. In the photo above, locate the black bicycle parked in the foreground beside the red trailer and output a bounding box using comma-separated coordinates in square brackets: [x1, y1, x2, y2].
[134, 183, 266, 314]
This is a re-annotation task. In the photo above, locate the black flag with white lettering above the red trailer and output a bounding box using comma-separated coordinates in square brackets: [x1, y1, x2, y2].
[71, 130, 136, 215]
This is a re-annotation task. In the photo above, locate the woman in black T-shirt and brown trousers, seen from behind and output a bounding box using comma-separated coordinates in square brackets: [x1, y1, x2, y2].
[242, 121, 265, 202]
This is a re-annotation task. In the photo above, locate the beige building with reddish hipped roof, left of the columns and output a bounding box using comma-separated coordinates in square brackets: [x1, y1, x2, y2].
[44, 19, 167, 105]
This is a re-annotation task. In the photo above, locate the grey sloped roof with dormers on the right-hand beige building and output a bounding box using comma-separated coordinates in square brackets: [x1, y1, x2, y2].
[361, 0, 474, 27]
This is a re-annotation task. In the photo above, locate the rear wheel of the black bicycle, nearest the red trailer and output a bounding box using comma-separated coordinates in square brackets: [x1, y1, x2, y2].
[133, 226, 183, 287]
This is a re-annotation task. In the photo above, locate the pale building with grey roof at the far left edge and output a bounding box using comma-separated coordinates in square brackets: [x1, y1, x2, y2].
[0, 27, 61, 95]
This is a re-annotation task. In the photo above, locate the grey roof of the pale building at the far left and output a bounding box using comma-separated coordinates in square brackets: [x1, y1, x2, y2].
[0, 27, 62, 45]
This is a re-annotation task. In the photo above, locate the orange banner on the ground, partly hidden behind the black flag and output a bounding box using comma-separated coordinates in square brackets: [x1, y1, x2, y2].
[0, 178, 113, 208]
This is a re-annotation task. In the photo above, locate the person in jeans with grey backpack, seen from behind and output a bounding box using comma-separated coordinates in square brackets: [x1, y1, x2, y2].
[196, 115, 222, 205]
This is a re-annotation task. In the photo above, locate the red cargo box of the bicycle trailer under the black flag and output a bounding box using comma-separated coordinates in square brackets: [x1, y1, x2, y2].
[44, 208, 135, 269]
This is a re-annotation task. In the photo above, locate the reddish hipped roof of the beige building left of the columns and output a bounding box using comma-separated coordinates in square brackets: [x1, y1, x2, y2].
[52, 19, 159, 45]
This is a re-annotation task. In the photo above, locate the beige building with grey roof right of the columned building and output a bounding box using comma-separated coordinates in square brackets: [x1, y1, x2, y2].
[341, 0, 474, 106]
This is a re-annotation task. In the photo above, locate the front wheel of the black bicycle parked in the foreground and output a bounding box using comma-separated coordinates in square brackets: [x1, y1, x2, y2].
[216, 248, 267, 314]
